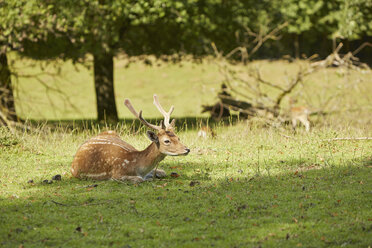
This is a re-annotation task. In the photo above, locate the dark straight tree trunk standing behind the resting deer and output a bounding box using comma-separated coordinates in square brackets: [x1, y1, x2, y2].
[93, 53, 118, 122]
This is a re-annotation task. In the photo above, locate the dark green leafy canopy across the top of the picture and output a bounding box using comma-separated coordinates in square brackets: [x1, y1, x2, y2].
[0, 0, 372, 60]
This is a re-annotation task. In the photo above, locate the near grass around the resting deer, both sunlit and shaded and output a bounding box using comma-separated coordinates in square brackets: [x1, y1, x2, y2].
[0, 122, 372, 247]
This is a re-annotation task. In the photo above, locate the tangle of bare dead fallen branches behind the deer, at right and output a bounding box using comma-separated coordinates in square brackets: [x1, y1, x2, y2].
[202, 34, 372, 125]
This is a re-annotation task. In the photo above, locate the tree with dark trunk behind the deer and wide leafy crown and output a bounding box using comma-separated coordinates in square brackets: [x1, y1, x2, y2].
[2, 0, 290, 122]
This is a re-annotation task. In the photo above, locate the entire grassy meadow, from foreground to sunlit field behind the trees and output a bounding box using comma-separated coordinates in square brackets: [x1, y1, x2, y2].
[0, 56, 372, 247]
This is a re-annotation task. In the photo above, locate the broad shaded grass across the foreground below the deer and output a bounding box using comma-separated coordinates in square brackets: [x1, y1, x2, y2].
[0, 157, 372, 247]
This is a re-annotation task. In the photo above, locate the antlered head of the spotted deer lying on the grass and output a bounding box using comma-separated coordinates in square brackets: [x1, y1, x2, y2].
[124, 94, 190, 156]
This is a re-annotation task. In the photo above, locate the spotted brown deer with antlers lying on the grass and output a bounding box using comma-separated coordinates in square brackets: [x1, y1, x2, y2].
[71, 95, 190, 183]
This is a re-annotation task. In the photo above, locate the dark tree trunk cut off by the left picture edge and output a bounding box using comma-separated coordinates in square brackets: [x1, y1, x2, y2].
[0, 52, 18, 122]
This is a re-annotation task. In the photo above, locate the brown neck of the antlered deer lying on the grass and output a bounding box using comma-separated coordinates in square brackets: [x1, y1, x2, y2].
[139, 142, 166, 176]
